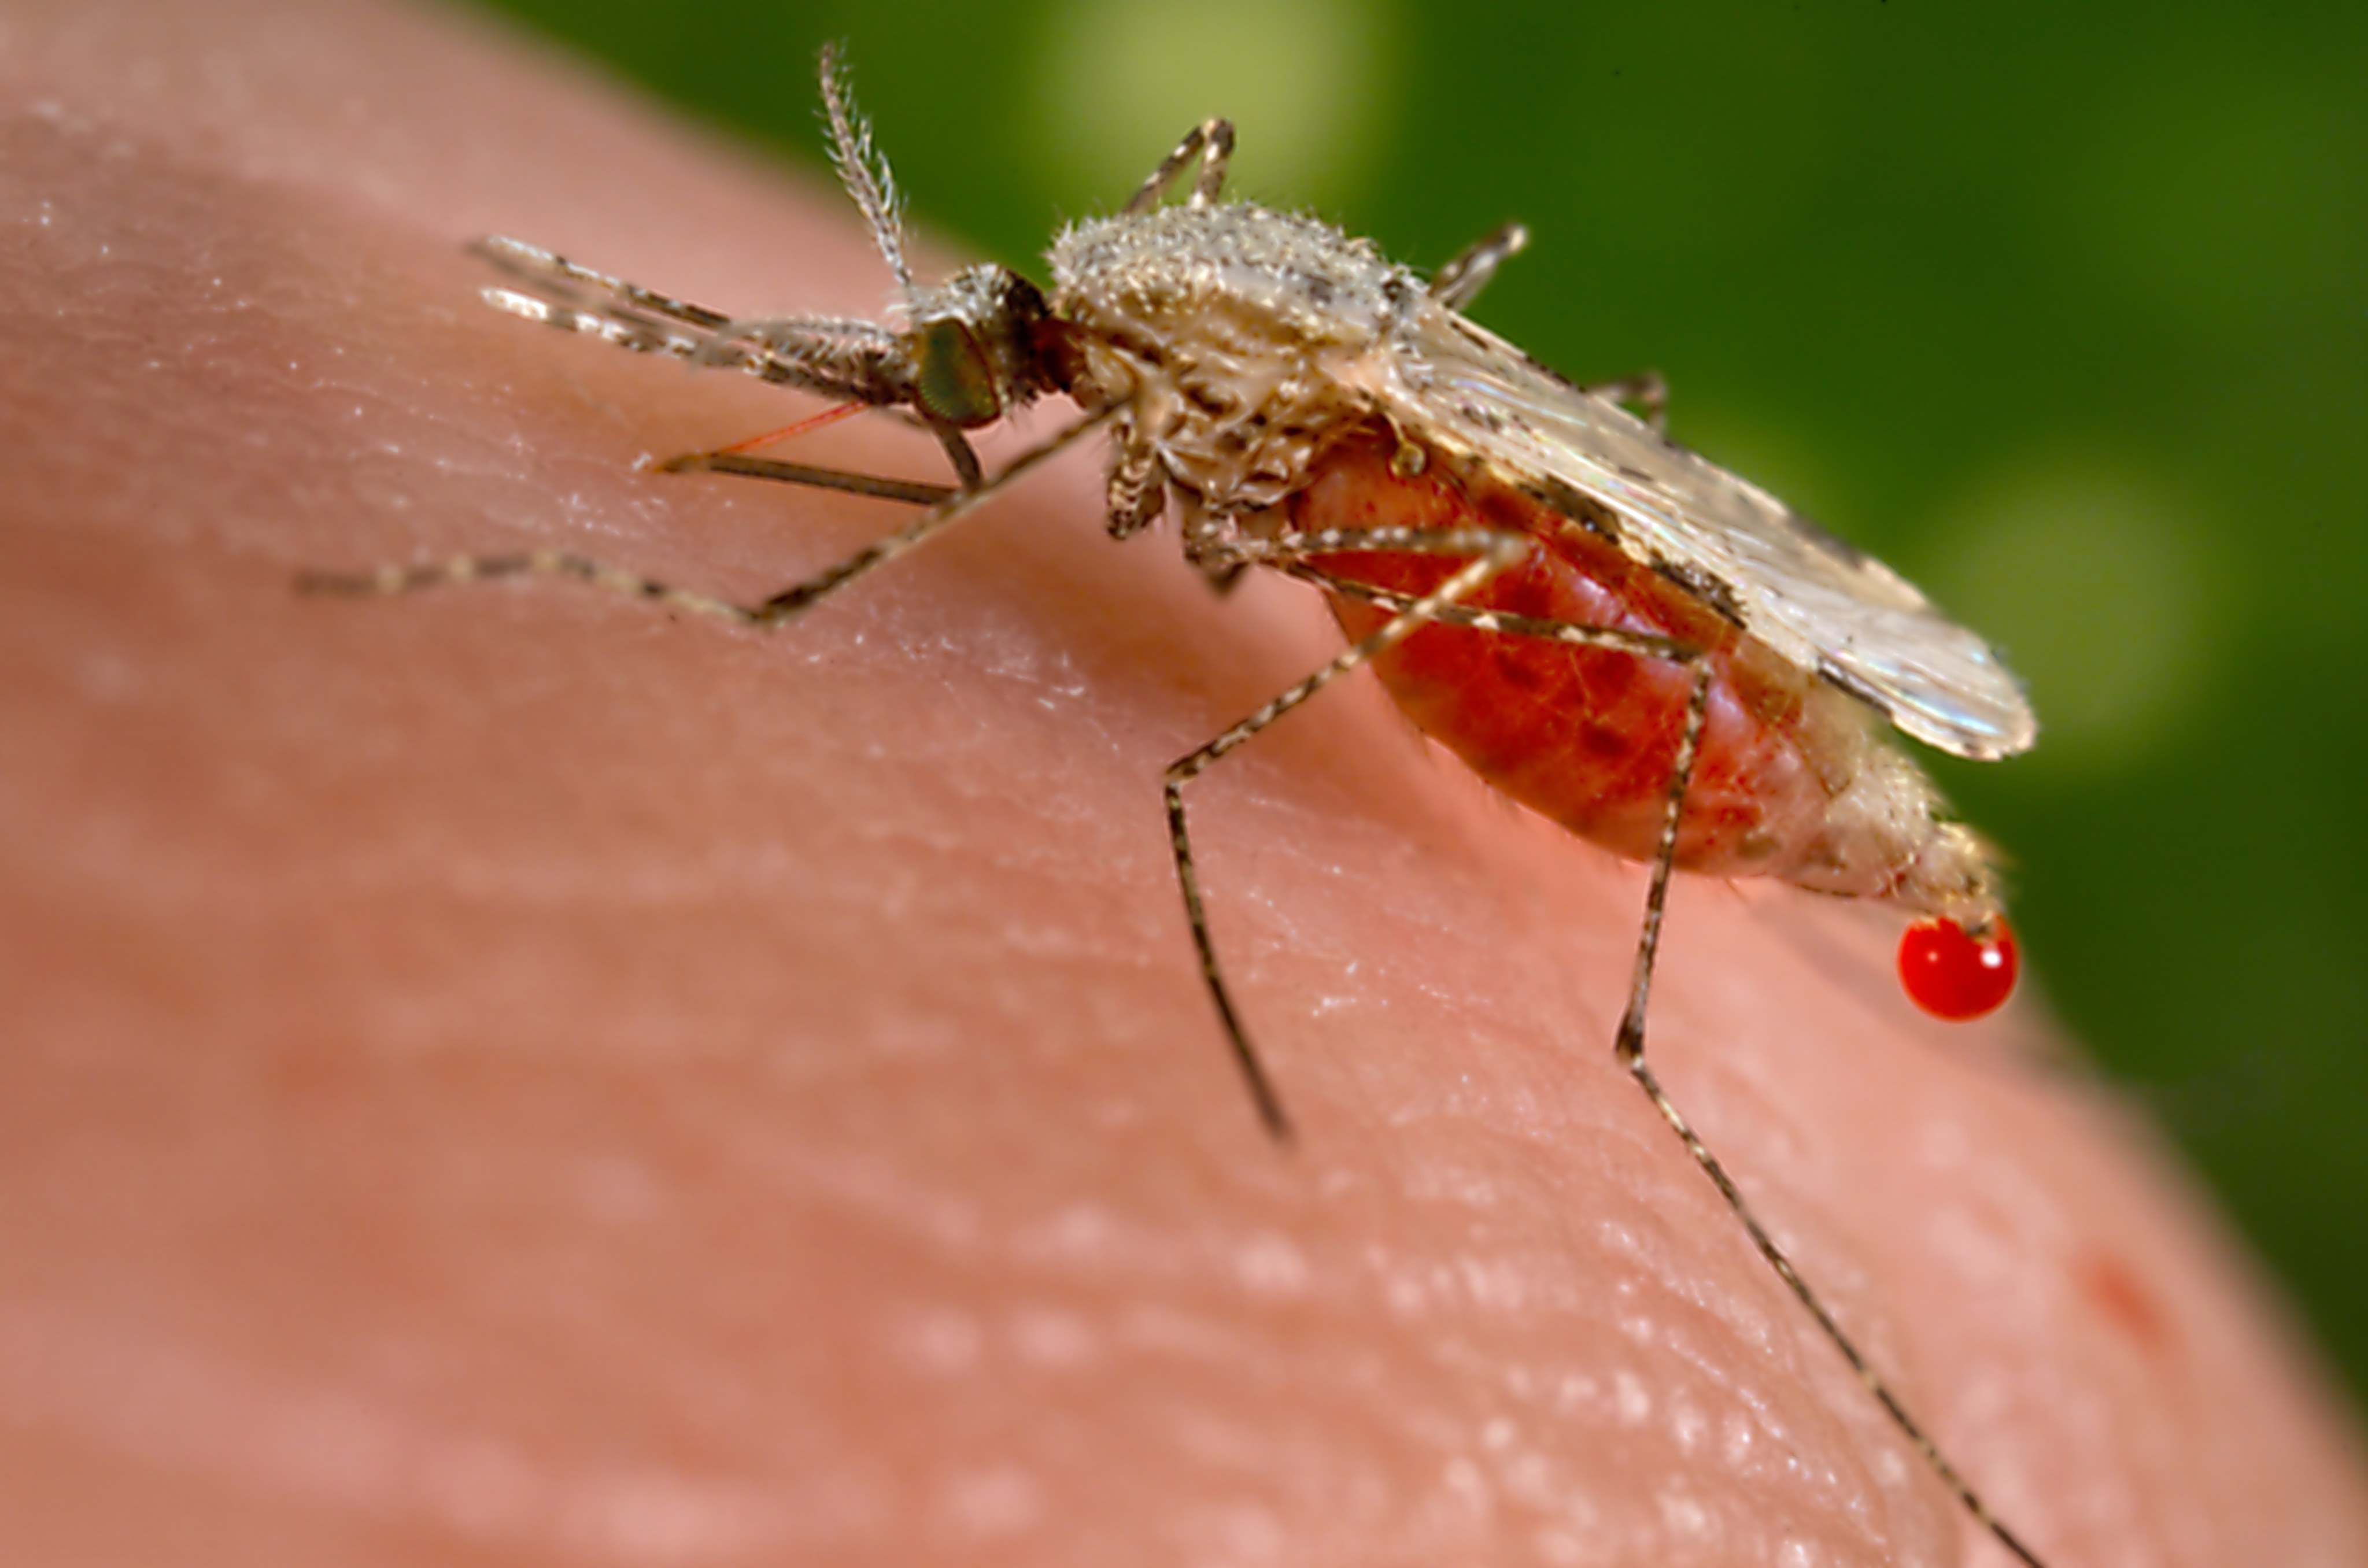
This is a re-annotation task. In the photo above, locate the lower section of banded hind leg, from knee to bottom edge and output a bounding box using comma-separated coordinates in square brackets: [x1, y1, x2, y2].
[1613, 663, 2044, 1568]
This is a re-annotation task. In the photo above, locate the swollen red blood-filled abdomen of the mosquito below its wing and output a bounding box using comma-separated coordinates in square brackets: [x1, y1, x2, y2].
[1286, 431, 1849, 877]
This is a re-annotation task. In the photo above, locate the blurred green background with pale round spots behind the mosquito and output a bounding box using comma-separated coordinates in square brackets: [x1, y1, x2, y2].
[466, 0, 2368, 1391]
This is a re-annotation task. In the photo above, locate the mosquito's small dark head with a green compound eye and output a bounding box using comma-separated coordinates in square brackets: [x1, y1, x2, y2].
[902, 265, 1056, 428]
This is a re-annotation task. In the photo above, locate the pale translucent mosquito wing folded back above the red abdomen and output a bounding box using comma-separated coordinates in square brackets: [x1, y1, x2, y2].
[1354, 303, 2039, 760]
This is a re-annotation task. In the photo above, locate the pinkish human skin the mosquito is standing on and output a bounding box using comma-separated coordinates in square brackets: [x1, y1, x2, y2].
[0, 0, 2368, 1568]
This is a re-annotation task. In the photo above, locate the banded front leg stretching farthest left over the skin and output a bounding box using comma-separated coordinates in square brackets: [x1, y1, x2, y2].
[296, 408, 1118, 630]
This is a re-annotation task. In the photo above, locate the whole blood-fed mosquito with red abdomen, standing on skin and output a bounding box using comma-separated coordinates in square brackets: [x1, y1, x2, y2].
[305, 47, 2039, 1568]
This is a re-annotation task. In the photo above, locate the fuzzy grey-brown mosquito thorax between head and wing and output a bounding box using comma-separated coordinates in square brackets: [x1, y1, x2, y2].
[1049, 204, 1423, 512]
